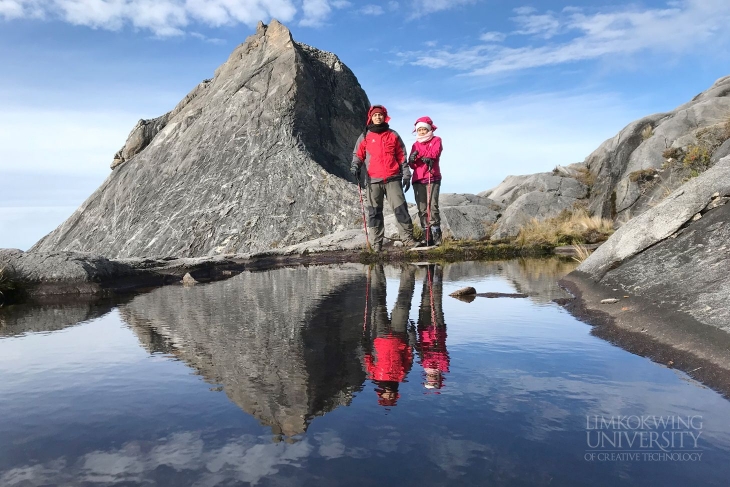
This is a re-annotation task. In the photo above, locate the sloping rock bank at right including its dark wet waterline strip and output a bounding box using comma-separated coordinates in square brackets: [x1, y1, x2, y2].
[561, 157, 730, 390]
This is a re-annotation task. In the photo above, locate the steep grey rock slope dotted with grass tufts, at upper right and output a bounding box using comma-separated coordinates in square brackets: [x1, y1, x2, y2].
[585, 76, 730, 224]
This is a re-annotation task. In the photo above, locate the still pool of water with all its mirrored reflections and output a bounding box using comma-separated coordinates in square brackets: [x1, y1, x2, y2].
[0, 259, 730, 487]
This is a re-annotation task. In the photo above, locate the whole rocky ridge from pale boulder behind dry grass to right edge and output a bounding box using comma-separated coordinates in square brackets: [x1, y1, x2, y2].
[460, 76, 730, 240]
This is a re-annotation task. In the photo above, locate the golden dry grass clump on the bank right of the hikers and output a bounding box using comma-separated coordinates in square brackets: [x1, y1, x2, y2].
[515, 208, 614, 247]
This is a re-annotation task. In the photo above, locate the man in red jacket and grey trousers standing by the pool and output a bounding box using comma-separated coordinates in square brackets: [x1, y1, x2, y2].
[350, 105, 416, 252]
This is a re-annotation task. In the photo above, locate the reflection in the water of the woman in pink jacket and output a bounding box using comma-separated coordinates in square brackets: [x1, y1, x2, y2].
[416, 264, 449, 389]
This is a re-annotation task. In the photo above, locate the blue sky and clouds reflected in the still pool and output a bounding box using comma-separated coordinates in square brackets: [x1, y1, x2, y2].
[0, 264, 730, 486]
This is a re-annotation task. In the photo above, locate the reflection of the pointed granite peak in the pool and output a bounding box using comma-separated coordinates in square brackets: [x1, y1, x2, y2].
[120, 265, 365, 436]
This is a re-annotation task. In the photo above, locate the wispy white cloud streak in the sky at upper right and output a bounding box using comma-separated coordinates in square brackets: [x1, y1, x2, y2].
[401, 0, 730, 75]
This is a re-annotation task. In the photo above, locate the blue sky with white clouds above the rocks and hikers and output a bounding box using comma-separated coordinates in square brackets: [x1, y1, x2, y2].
[0, 0, 730, 249]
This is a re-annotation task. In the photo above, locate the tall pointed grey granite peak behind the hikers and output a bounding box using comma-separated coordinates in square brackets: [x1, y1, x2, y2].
[32, 21, 369, 258]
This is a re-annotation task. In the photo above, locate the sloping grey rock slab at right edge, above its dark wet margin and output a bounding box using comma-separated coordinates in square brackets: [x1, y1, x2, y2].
[568, 156, 730, 332]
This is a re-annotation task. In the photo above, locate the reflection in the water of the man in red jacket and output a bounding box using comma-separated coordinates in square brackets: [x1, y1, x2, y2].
[364, 264, 415, 406]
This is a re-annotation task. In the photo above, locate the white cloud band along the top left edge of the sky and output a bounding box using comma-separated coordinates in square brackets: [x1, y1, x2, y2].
[0, 0, 302, 37]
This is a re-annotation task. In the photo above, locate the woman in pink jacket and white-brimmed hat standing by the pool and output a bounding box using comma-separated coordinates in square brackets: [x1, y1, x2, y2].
[408, 117, 443, 246]
